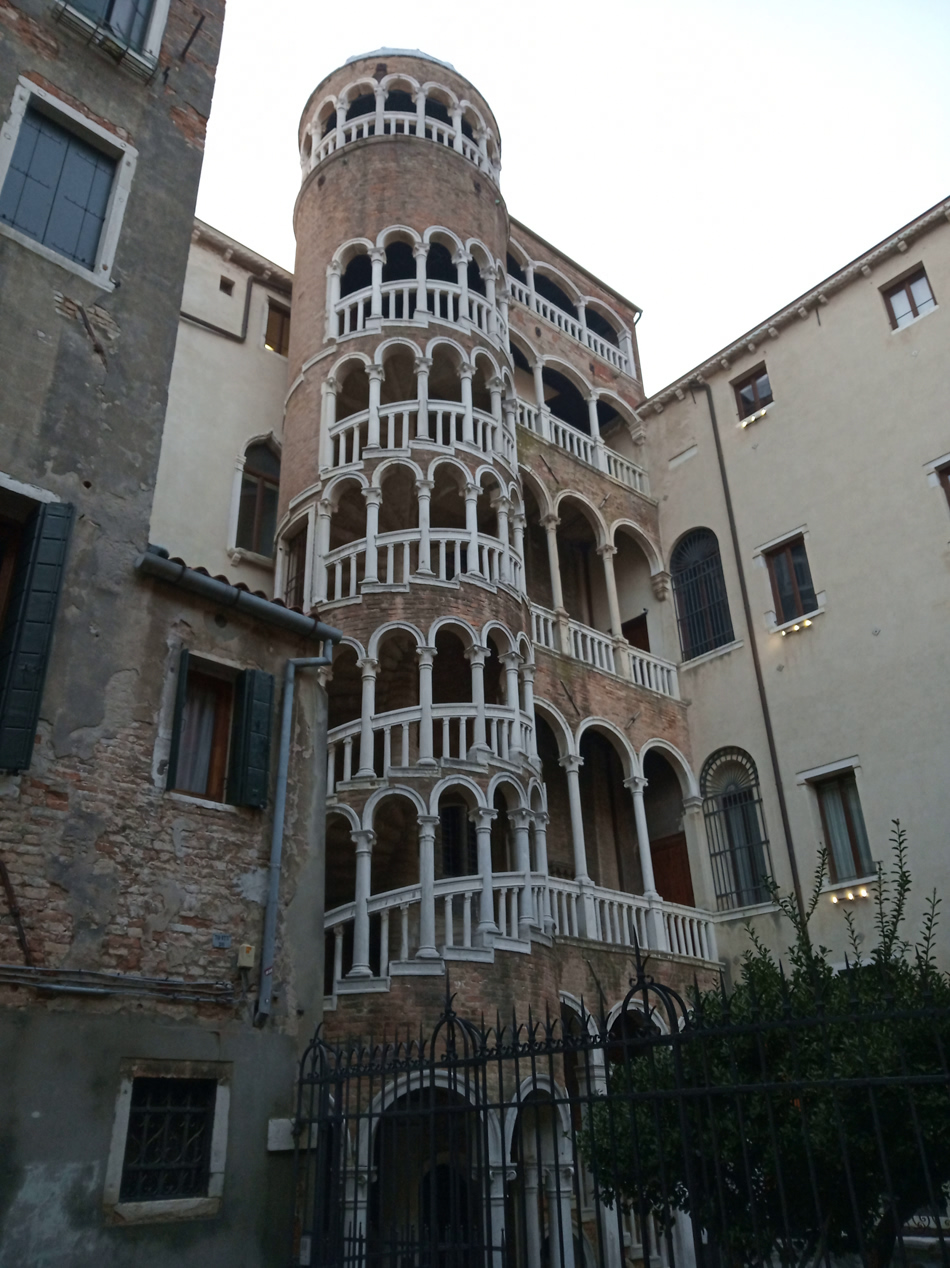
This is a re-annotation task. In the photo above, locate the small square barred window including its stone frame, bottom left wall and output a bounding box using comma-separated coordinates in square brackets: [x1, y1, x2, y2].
[103, 1060, 231, 1224]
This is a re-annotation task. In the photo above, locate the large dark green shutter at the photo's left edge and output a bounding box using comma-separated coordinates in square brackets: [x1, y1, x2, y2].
[0, 502, 72, 771]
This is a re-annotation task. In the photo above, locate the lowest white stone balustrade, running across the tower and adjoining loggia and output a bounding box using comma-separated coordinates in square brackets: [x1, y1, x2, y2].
[323, 872, 718, 990]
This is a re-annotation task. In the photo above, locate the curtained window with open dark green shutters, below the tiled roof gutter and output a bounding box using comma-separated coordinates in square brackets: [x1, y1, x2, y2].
[166, 650, 274, 809]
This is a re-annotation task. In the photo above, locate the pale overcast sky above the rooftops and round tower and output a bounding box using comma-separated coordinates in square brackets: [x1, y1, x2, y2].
[192, 0, 950, 392]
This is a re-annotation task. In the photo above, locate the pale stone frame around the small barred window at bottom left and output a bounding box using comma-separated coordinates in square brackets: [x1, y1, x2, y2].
[103, 1060, 232, 1224]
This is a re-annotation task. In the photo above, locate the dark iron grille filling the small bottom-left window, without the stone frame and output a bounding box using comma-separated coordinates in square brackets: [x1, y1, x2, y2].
[119, 1078, 218, 1202]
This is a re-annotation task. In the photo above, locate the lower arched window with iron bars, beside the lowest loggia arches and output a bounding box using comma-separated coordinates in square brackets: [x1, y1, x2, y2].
[699, 748, 771, 912]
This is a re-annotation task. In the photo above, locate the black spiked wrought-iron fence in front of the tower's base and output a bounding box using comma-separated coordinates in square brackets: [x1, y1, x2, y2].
[292, 956, 950, 1268]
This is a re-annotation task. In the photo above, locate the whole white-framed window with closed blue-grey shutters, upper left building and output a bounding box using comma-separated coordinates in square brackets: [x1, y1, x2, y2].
[0, 79, 137, 290]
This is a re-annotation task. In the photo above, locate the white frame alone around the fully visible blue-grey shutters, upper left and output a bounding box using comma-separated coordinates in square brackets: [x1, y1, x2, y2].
[0, 75, 138, 290]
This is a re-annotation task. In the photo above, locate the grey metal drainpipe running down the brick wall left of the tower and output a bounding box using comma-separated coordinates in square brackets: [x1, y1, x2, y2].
[254, 649, 342, 1026]
